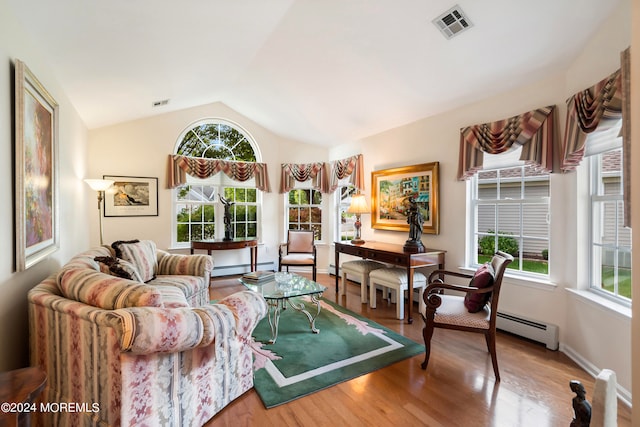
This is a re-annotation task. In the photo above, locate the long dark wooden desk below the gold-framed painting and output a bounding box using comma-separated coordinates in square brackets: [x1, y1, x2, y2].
[335, 242, 446, 323]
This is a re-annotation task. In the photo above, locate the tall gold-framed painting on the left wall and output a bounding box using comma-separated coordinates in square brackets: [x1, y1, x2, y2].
[14, 60, 60, 271]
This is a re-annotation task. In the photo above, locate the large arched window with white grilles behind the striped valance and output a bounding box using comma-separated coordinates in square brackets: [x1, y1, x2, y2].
[173, 119, 260, 247]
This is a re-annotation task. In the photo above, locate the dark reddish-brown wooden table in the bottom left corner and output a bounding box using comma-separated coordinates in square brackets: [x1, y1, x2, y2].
[0, 367, 47, 426]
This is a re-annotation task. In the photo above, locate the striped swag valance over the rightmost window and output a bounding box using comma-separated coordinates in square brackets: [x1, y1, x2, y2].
[561, 70, 622, 172]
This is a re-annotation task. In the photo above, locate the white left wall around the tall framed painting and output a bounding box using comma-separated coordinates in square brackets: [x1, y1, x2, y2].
[0, 0, 90, 371]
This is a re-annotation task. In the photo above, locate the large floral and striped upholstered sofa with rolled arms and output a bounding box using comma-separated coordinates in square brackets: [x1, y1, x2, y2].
[28, 241, 266, 426]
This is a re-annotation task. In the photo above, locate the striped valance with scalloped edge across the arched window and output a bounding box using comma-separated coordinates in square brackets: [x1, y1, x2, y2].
[167, 154, 271, 192]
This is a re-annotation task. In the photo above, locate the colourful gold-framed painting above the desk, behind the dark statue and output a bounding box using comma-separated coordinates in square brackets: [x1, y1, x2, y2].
[371, 162, 440, 234]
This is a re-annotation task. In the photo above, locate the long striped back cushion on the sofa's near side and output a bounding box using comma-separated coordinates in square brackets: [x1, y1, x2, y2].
[58, 268, 163, 310]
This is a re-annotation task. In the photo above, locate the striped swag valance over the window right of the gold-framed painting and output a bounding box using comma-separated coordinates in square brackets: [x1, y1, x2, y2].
[458, 105, 555, 180]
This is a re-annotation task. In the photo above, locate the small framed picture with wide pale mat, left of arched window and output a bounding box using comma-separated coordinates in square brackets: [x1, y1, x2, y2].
[102, 175, 158, 217]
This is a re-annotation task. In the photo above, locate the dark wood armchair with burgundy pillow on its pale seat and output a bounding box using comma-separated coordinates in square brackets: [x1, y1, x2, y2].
[422, 252, 513, 381]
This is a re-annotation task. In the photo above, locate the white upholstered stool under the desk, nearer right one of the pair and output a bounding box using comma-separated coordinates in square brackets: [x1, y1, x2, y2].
[369, 268, 427, 319]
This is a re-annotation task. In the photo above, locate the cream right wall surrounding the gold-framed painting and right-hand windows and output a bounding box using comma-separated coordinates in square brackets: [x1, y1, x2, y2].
[330, 1, 637, 400]
